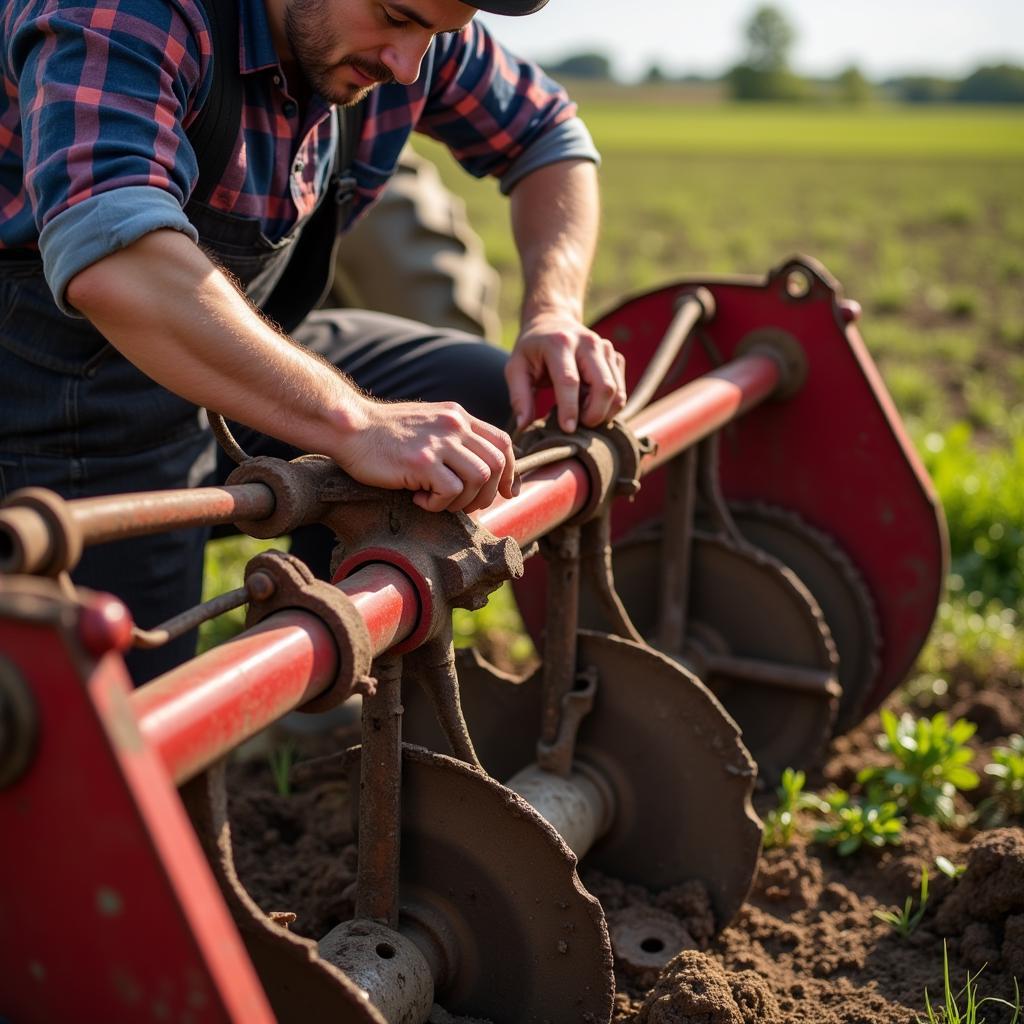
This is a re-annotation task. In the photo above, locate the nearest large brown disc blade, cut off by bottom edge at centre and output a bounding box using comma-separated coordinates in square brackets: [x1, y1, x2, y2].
[348, 744, 614, 1024]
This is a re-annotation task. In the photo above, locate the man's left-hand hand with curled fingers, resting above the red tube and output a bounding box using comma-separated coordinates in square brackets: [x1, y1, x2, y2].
[328, 398, 519, 512]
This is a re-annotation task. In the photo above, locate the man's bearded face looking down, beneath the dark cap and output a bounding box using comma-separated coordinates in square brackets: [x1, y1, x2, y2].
[281, 0, 474, 105]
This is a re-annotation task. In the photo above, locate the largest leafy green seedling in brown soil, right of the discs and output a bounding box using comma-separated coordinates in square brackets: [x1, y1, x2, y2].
[857, 710, 980, 824]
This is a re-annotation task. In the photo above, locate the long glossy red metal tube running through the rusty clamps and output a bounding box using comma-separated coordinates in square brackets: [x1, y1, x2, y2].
[132, 354, 780, 782]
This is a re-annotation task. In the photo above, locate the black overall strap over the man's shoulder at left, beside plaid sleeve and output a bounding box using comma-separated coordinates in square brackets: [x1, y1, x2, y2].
[186, 0, 243, 203]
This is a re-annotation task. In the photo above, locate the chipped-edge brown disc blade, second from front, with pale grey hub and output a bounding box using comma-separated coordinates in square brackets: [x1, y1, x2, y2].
[402, 631, 761, 928]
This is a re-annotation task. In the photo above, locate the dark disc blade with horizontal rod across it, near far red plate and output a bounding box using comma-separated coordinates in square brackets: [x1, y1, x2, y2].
[593, 523, 840, 785]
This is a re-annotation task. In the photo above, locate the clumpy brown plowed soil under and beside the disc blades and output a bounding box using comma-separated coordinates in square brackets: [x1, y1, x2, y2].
[230, 681, 1024, 1024]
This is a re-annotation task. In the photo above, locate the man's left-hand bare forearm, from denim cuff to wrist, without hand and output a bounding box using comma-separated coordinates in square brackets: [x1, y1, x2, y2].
[67, 230, 364, 456]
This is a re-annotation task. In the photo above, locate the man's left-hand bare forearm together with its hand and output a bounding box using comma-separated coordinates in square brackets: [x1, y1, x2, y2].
[67, 230, 517, 512]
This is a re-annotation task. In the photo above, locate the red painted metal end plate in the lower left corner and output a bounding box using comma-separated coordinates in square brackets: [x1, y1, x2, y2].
[0, 589, 274, 1024]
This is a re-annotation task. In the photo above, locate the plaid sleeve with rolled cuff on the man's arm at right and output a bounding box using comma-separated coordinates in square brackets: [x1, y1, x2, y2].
[417, 22, 599, 191]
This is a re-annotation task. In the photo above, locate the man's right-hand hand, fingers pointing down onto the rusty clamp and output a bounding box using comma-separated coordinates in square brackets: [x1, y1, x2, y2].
[505, 312, 626, 433]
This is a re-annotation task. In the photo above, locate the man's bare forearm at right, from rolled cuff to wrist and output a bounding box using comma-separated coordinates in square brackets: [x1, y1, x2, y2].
[511, 161, 600, 325]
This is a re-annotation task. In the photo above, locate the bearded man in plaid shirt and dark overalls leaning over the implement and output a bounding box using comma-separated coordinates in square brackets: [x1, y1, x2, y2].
[0, 0, 625, 681]
